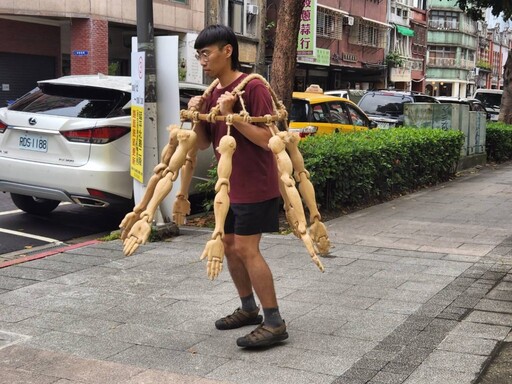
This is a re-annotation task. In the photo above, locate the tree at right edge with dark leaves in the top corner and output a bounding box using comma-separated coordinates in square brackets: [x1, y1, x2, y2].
[457, 0, 512, 124]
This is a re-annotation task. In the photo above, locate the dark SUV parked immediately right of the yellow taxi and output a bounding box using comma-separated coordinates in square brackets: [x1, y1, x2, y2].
[357, 91, 439, 129]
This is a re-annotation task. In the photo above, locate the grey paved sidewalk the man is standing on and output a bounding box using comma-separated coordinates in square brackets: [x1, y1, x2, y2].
[0, 164, 512, 384]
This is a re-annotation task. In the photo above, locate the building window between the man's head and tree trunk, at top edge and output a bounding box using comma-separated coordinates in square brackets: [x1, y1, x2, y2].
[220, 0, 259, 37]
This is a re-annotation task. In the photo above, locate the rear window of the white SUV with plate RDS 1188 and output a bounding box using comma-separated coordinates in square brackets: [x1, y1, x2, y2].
[8, 84, 131, 119]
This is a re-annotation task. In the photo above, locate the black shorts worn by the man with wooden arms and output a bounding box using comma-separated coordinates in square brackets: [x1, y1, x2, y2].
[224, 197, 280, 236]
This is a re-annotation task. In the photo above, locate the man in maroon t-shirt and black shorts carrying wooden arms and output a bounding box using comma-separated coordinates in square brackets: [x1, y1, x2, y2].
[189, 25, 288, 348]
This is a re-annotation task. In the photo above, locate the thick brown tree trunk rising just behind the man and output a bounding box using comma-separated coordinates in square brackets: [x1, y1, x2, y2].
[270, 0, 304, 111]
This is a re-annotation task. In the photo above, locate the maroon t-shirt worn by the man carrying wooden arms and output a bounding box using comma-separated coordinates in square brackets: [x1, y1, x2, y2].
[206, 74, 280, 204]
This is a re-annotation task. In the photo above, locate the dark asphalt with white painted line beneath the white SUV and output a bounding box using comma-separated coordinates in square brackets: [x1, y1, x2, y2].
[0, 192, 130, 255]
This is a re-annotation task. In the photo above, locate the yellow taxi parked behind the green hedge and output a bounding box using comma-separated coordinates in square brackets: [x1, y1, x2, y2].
[288, 85, 377, 137]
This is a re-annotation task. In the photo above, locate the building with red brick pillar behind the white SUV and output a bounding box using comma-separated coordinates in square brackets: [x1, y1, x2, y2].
[0, 0, 206, 106]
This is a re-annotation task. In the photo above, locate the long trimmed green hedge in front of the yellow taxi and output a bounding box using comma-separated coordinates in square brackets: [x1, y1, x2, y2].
[300, 128, 464, 209]
